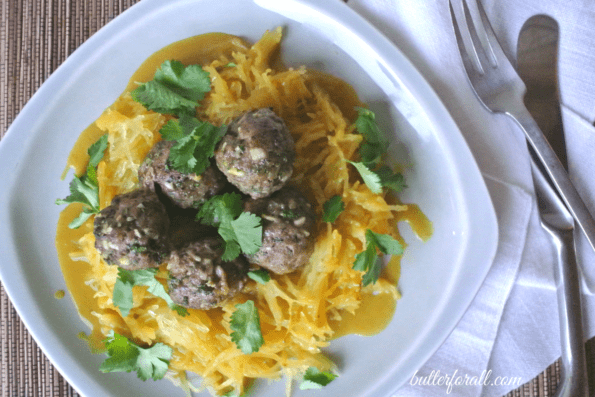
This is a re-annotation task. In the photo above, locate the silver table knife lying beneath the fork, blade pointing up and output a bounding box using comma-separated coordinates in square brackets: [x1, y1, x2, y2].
[517, 15, 588, 397]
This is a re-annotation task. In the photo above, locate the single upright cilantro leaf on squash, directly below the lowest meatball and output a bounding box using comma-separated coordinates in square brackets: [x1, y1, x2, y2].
[230, 300, 264, 354]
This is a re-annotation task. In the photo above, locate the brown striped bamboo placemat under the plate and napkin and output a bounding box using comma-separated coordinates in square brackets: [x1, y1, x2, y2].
[0, 0, 595, 397]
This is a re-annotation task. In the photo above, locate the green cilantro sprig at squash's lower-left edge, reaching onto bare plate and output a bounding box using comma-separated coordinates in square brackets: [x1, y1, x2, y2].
[99, 330, 173, 380]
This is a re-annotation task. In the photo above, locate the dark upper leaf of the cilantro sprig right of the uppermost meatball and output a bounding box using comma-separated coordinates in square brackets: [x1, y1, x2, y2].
[355, 107, 389, 163]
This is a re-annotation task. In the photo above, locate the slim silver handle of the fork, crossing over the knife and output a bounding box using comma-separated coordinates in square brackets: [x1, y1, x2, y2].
[507, 105, 595, 250]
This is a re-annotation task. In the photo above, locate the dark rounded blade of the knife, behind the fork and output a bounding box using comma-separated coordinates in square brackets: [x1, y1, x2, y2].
[517, 15, 568, 171]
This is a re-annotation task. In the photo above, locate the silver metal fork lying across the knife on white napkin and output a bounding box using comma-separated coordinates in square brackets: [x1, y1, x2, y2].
[449, 0, 595, 254]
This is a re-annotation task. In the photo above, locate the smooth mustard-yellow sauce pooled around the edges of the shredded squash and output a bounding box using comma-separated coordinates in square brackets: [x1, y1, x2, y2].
[56, 33, 432, 350]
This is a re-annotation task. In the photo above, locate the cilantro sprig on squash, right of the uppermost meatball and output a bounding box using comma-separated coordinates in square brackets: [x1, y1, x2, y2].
[349, 108, 407, 194]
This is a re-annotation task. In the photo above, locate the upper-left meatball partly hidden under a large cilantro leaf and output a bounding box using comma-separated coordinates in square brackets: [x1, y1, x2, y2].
[138, 141, 227, 208]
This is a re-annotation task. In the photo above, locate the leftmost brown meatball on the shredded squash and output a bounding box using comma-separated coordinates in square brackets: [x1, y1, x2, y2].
[93, 189, 169, 270]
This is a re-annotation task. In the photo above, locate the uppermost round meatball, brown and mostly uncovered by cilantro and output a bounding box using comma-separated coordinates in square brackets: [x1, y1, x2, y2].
[215, 108, 295, 198]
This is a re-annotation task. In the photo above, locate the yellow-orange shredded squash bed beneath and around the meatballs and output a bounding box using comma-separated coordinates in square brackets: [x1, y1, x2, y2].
[67, 29, 407, 395]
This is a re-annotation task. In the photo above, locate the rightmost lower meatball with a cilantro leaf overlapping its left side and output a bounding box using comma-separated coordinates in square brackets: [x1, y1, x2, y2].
[244, 187, 316, 274]
